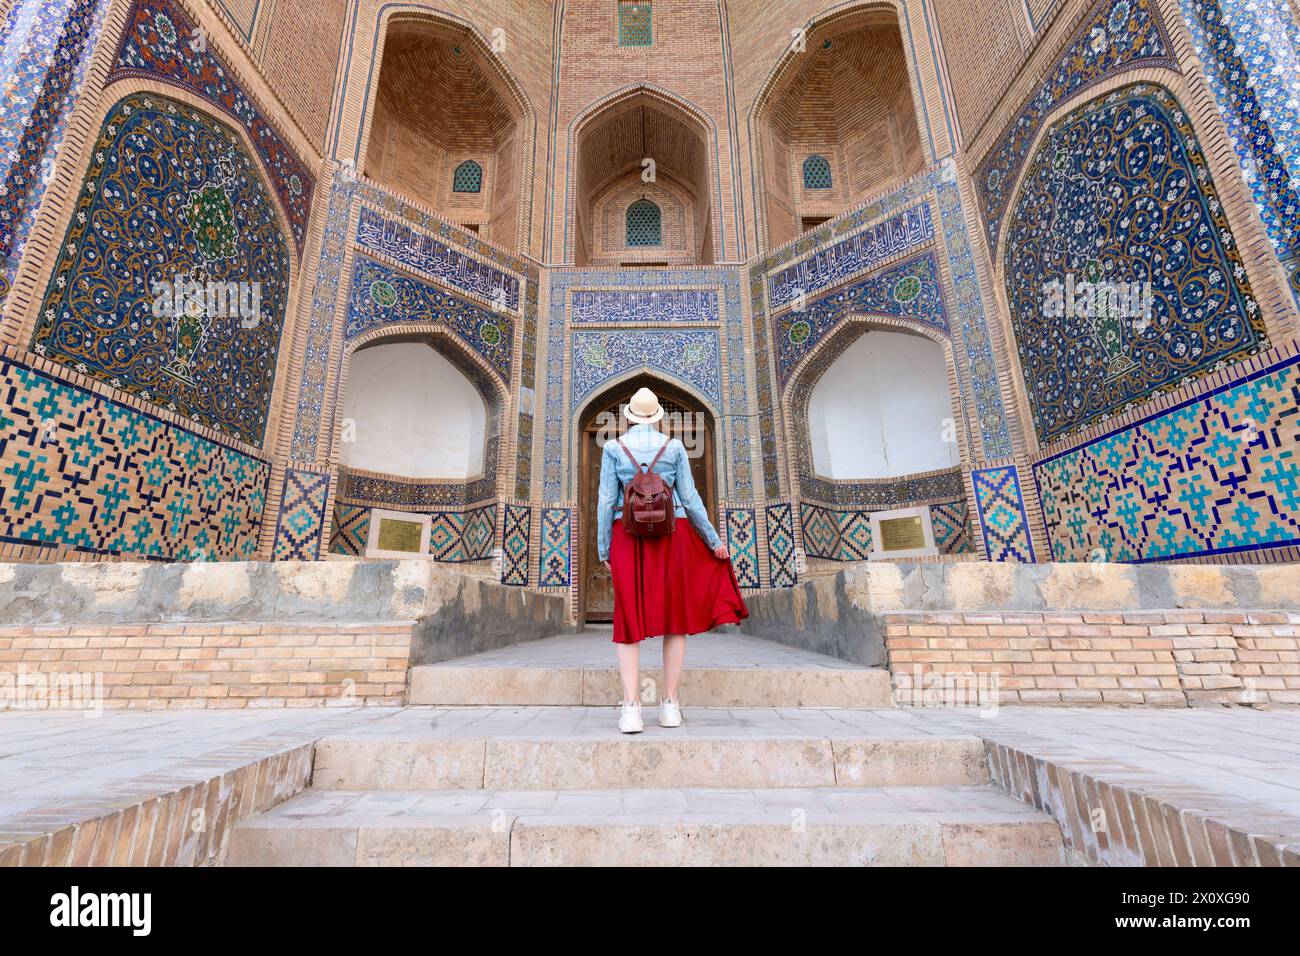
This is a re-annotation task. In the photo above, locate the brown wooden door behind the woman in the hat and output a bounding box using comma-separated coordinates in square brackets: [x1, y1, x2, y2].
[579, 380, 718, 623]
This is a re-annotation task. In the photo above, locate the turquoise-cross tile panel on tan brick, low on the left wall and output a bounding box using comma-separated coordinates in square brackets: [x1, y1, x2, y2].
[0, 359, 270, 561]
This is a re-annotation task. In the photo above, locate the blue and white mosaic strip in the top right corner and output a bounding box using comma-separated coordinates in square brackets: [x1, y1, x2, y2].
[1182, 0, 1300, 303]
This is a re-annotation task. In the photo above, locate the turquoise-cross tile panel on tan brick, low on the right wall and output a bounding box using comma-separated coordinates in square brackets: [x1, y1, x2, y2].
[1034, 358, 1300, 562]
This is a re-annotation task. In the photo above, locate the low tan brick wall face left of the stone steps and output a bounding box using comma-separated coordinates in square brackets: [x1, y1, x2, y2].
[0, 622, 412, 709]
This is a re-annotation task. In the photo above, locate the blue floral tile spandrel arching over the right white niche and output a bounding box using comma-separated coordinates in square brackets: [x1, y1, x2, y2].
[775, 252, 949, 385]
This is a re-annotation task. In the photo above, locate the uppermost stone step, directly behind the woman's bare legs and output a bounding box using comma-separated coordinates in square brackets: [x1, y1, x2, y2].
[410, 630, 891, 708]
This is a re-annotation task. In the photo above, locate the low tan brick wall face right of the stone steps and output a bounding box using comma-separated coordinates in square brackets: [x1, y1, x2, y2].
[884, 610, 1300, 706]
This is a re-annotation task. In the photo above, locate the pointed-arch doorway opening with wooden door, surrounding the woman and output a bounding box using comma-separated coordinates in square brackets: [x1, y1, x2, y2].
[577, 375, 722, 622]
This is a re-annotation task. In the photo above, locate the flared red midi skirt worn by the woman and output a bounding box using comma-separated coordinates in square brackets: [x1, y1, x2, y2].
[610, 518, 749, 644]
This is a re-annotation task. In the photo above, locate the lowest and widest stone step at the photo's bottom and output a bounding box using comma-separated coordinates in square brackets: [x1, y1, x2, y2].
[226, 787, 1065, 866]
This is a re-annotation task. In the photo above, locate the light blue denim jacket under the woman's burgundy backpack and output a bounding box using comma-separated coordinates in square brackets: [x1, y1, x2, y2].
[595, 425, 722, 561]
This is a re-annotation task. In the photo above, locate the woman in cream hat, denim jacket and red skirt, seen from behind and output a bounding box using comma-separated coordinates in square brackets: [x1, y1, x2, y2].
[595, 389, 749, 734]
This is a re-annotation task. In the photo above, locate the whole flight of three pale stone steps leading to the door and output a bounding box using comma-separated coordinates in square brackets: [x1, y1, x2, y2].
[226, 632, 1065, 866]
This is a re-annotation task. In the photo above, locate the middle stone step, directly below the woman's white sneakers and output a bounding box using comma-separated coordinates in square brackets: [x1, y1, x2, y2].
[312, 708, 989, 791]
